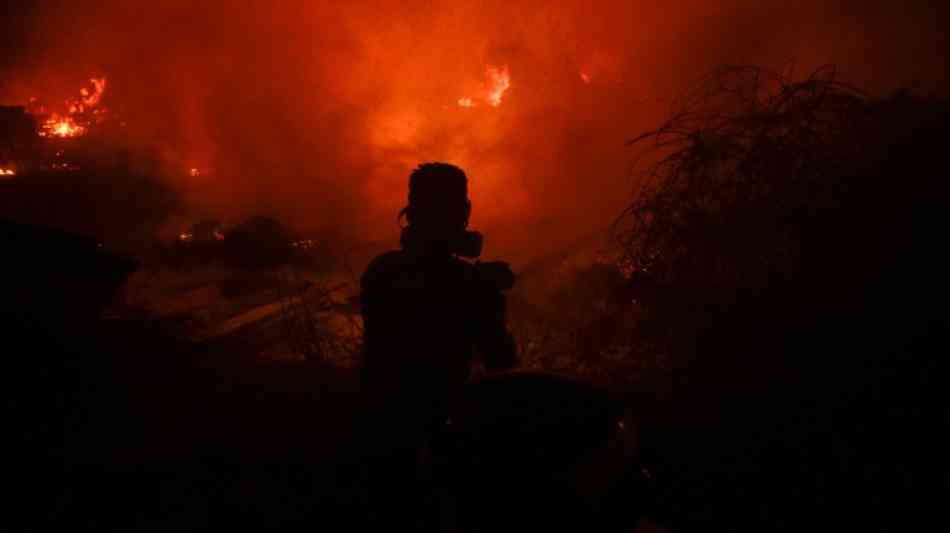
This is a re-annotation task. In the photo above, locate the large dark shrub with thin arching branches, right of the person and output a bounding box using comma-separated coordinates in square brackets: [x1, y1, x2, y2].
[617, 67, 950, 372]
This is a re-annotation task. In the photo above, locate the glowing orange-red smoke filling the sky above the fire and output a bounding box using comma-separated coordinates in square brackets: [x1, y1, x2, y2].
[0, 0, 947, 262]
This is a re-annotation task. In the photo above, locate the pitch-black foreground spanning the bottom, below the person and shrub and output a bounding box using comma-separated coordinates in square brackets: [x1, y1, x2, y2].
[3, 217, 945, 531]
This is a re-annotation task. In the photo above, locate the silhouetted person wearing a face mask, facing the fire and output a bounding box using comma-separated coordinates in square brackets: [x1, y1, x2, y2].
[361, 163, 516, 520]
